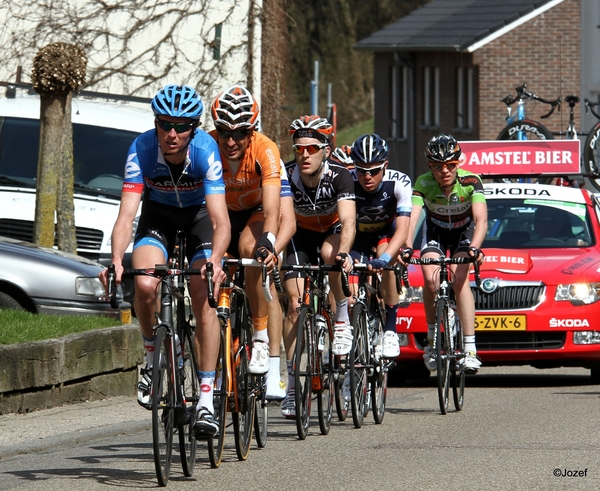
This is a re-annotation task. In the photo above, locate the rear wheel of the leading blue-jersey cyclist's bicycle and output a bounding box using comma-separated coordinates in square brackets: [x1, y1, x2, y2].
[177, 318, 199, 477]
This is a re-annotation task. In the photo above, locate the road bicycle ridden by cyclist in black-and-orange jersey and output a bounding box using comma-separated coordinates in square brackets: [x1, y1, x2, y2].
[281, 261, 350, 440]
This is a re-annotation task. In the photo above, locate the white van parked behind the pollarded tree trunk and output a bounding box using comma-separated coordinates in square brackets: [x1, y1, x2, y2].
[0, 84, 154, 298]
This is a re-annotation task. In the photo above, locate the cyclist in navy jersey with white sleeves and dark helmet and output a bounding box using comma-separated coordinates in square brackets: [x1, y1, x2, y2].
[347, 134, 412, 362]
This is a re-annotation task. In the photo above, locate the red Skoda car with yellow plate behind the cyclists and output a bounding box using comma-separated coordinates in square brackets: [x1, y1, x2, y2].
[396, 183, 600, 382]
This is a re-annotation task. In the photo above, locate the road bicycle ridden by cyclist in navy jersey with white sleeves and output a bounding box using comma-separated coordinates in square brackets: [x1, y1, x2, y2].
[346, 263, 406, 428]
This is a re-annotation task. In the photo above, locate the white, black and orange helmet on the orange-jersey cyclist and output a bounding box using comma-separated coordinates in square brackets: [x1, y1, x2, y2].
[211, 85, 260, 130]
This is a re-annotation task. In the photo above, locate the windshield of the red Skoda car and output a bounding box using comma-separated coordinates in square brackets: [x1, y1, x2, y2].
[483, 199, 595, 249]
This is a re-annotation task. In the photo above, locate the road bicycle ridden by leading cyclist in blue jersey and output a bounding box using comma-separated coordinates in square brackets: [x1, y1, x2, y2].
[108, 233, 201, 486]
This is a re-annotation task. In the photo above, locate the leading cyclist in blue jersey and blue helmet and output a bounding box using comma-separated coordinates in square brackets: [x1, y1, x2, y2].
[100, 85, 231, 435]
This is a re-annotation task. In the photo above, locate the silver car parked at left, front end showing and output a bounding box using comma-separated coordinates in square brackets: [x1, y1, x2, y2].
[0, 236, 131, 323]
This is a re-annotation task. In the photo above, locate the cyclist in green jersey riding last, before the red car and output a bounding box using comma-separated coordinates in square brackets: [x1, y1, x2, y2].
[401, 134, 487, 373]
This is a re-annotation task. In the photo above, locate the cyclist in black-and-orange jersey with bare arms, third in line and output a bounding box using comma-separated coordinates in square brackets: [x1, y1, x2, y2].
[281, 115, 356, 418]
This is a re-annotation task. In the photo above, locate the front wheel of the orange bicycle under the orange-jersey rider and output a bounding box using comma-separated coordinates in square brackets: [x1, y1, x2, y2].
[208, 326, 229, 469]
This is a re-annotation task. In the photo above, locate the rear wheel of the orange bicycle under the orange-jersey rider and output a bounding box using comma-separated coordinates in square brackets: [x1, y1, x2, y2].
[231, 292, 256, 460]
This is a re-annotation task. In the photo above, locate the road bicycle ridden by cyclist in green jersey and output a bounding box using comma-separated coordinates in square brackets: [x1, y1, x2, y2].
[410, 256, 481, 414]
